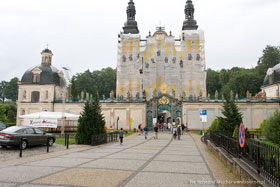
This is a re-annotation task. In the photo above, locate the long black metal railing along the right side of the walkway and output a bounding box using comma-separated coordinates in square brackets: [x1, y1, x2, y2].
[210, 132, 280, 186]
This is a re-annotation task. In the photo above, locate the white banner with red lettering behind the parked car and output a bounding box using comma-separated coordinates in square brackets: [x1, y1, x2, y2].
[24, 119, 57, 128]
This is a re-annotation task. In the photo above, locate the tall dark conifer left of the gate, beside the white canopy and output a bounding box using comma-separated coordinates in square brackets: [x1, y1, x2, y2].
[76, 94, 105, 145]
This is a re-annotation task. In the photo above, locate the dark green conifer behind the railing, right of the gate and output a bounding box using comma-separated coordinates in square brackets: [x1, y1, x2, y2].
[218, 96, 242, 136]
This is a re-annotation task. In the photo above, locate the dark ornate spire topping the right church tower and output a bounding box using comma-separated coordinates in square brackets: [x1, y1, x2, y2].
[183, 0, 198, 30]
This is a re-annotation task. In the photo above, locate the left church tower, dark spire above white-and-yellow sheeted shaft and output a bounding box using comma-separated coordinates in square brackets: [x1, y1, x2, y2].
[116, 0, 141, 98]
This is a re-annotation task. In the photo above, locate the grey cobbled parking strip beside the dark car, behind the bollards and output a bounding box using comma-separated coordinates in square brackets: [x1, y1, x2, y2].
[0, 144, 80, 162]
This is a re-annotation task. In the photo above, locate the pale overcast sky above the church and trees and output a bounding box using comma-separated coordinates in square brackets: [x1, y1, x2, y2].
[0, 0, 280, 81]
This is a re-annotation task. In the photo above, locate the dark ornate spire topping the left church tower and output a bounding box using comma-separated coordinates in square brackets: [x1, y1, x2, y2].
[123, 0, 139, 34]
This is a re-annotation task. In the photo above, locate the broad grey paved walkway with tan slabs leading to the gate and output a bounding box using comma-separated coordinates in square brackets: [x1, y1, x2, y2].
[0, 133, 216, 187]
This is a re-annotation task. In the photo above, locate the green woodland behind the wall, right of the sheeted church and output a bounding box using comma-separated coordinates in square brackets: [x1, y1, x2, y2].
[206, 46, 280, 97]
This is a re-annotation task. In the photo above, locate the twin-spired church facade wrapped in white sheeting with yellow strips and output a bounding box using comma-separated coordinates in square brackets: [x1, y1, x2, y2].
[116, 0, 207, 100]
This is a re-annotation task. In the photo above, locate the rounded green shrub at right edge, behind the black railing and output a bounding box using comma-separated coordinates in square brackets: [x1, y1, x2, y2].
[264, 110, 280, 145]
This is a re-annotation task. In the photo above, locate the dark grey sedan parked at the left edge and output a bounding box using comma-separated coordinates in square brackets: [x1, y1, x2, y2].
[0, 126, 56, 149]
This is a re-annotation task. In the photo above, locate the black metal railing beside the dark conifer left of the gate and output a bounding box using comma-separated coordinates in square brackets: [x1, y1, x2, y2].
[91, 132, 119, 146]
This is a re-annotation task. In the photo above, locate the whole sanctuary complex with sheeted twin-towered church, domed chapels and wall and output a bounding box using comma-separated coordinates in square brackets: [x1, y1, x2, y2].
[17, 0, 280, 130]
